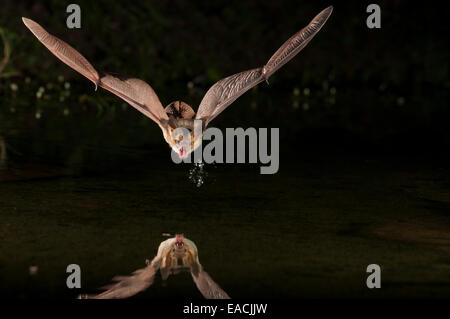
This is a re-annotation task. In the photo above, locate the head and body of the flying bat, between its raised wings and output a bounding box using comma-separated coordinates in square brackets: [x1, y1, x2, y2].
[164, 101, 203, 159]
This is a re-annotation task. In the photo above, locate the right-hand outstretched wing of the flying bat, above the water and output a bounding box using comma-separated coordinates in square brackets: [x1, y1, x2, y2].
[196, 6, 333, 126]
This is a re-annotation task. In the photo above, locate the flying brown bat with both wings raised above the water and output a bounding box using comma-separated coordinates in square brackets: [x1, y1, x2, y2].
[22, 6, 333, 158]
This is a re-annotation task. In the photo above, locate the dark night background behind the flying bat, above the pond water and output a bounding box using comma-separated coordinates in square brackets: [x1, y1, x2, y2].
[0, 0, 450, 156]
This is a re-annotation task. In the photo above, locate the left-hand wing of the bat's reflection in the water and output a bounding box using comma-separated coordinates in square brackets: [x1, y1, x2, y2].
[88, 258, 160, 299]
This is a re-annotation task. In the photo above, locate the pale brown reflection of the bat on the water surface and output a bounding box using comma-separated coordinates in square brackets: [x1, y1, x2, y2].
[81, 235, 230, 299]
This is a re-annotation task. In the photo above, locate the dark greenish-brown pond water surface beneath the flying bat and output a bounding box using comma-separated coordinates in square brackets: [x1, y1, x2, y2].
[0, 131, 450, 298]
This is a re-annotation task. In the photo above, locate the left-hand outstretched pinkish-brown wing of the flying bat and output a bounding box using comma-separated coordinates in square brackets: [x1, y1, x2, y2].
[22, 18, 168, 126]
